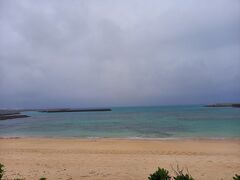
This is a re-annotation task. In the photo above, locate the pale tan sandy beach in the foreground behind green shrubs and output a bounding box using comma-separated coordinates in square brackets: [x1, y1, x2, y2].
[0, 138, 240, 180]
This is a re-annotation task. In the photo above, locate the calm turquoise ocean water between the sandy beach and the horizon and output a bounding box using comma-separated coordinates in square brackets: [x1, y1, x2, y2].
[0, 106, 240, 138]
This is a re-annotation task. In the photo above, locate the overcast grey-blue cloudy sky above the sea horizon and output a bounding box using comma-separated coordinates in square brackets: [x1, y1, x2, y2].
[0, 0, 240, 108]
